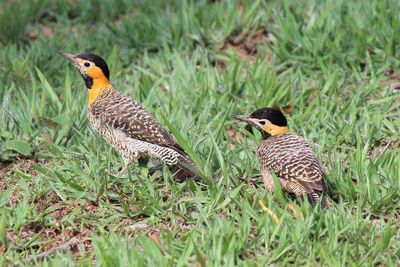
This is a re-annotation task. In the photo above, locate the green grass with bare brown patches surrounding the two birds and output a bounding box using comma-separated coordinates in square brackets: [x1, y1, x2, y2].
[0, 0, 400, 266]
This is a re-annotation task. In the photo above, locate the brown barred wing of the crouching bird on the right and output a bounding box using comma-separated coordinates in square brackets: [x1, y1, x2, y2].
[258, 134, 327, 193]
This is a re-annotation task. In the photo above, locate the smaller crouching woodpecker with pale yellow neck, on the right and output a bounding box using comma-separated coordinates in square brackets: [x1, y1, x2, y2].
[233, 108, 331, 209]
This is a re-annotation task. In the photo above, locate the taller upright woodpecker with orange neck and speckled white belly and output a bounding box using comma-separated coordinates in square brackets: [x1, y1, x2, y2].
[58, 51, 202, 181]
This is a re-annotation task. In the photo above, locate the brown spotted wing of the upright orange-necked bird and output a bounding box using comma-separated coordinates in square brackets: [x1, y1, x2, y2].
[89, 89, 186, 155]
